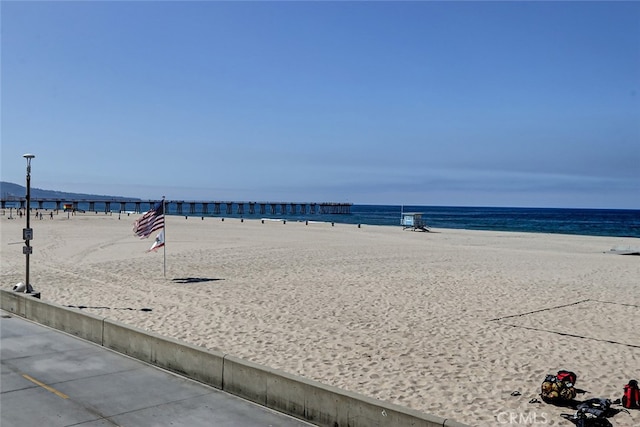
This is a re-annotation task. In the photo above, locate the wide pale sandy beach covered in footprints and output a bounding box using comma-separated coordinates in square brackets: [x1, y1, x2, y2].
[0, 211, 640, 427]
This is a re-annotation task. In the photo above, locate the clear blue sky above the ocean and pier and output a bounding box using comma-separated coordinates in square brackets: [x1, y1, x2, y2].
[0, 1, 640, 209]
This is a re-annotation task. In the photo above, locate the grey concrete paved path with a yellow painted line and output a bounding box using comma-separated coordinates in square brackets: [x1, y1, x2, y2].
[0, 311, 312, 427]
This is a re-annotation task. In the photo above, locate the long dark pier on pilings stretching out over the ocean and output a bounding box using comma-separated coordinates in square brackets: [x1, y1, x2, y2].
[0, 197, 352, 216]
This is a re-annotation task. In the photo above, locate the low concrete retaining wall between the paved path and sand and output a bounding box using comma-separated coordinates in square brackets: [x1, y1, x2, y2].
[0, 289, 468, 427]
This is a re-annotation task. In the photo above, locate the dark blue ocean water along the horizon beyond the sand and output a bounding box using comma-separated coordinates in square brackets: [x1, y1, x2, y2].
[16, 202, 640, 237]
